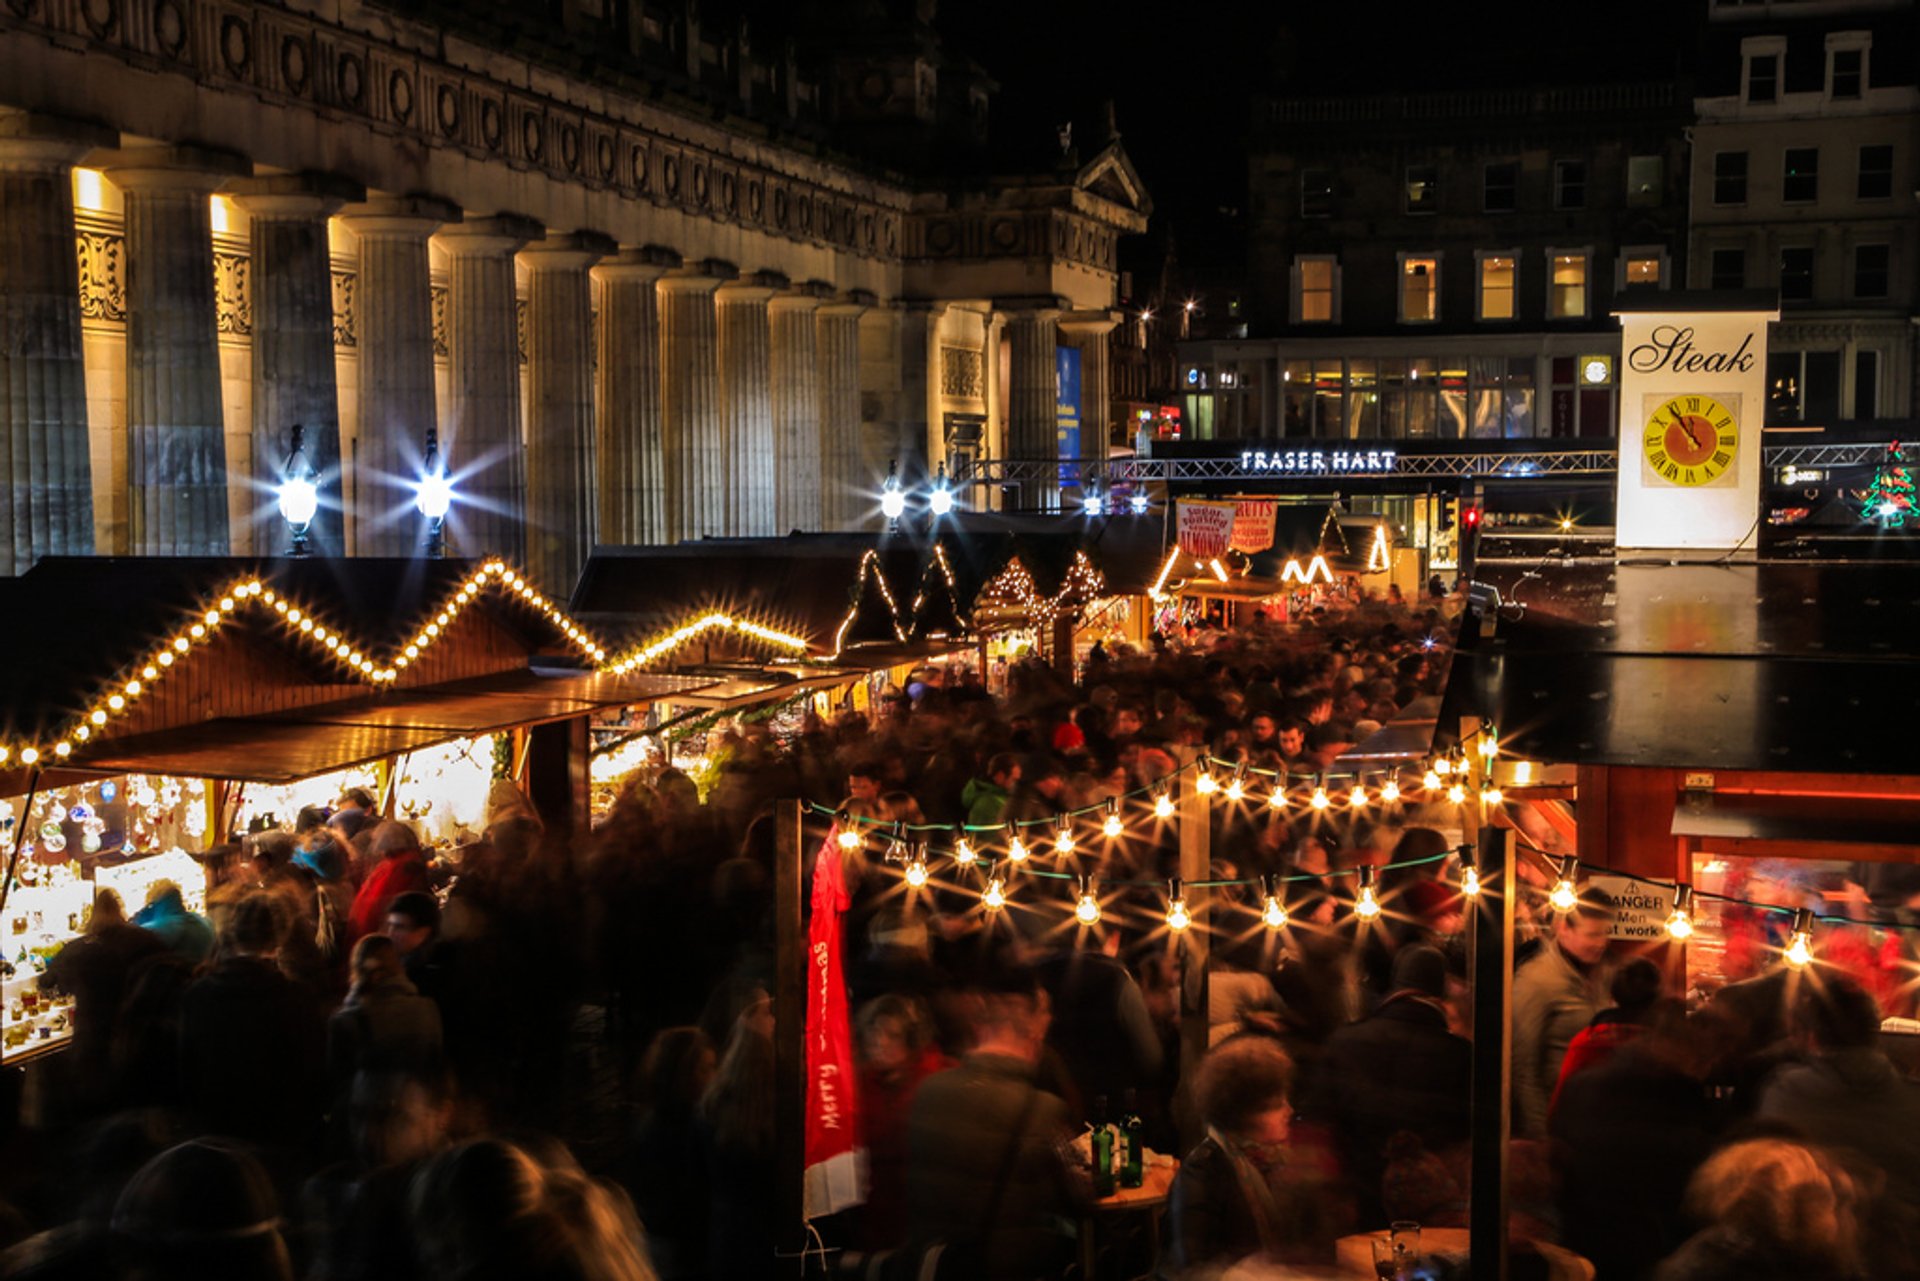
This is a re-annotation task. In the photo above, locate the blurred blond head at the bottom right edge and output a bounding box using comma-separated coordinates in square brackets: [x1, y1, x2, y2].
[1653, 1139, 1882, 1281]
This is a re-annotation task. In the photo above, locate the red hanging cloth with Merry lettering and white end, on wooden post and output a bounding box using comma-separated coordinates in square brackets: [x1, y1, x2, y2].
[803, 828, 866, 1220]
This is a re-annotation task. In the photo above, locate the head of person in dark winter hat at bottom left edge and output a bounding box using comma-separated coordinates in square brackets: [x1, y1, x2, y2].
[113, 1139, 294, 1281]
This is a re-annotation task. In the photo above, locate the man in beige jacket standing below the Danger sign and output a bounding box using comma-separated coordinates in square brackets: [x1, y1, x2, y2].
[1513, 885, 1613, 1139]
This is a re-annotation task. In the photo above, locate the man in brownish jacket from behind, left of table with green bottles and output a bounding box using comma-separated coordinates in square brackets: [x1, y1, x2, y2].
[906, 966, 1085, 1281]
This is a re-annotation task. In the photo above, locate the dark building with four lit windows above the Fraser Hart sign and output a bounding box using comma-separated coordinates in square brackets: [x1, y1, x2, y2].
[1179, 79, 1692, 451]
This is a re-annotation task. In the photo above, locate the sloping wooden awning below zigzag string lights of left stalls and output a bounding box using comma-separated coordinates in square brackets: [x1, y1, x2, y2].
[72, 672, 716, 784]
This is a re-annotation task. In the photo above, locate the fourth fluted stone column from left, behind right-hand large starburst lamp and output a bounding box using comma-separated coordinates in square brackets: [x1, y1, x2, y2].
[342, 196, 465, 557]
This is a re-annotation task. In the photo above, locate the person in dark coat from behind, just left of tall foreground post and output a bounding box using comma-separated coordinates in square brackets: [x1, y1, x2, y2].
[1302, 943, 1473, 1223]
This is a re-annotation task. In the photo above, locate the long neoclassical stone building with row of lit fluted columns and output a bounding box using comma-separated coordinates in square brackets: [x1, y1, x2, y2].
[0, 0, 1148, 590]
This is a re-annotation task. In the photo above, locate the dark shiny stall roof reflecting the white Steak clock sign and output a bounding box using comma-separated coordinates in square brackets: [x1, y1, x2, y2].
[1440, 561, 1920, 774]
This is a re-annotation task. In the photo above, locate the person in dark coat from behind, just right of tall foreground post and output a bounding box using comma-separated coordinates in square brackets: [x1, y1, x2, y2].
[1551, 1001, 1715, 1281]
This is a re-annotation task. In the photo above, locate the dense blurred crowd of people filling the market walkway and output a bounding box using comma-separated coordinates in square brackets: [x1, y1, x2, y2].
[0, 583, 1920, 1281]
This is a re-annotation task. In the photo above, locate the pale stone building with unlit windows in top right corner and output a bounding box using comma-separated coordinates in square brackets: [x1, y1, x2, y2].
[1688, 0, 1920, 426]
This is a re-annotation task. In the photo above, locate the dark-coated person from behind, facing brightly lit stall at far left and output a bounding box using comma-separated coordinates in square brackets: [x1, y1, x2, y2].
[180, 893, 326, 1152]
